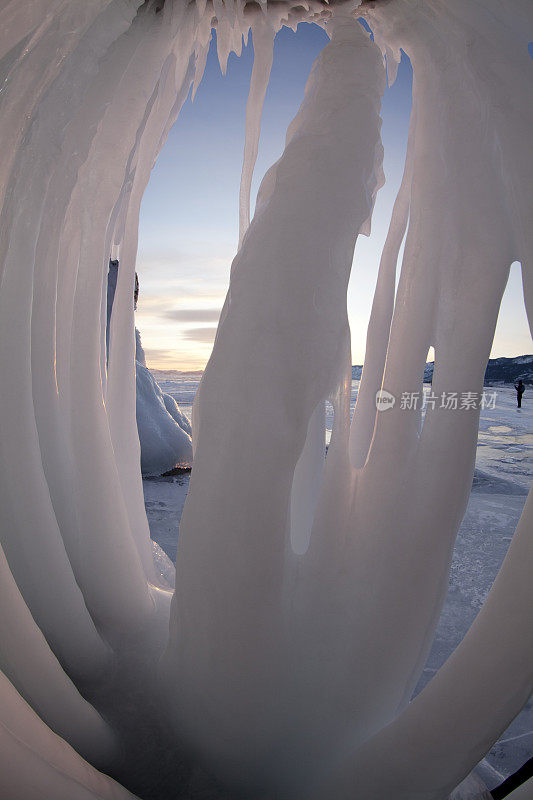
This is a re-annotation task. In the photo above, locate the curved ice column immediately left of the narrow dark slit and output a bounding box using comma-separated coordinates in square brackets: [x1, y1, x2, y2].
[59, 1, 181, 635]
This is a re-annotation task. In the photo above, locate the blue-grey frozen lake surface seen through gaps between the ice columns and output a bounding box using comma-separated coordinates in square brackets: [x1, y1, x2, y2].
[143, 374, 533, 788]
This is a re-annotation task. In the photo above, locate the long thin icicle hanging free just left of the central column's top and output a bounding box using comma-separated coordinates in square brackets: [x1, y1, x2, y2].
[239, 17, 275, 247]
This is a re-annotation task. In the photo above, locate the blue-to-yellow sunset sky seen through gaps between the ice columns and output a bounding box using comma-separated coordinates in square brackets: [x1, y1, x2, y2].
[136, 23, 532, 371]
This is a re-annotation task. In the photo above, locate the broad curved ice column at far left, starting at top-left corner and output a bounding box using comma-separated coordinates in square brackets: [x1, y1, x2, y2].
[0, 3, 139, 674]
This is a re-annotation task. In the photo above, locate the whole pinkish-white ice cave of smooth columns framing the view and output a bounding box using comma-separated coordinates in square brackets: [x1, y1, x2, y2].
[0, 0, 533, 800]
